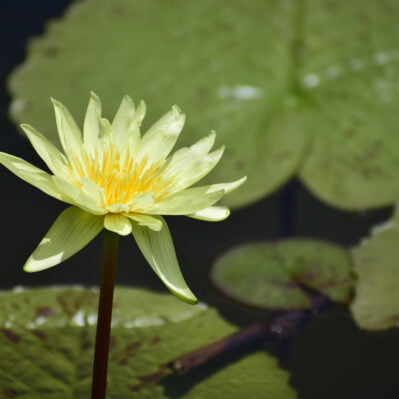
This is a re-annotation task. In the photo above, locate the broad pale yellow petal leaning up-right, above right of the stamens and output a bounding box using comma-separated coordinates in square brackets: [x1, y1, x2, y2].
[137, 106, 185, 165]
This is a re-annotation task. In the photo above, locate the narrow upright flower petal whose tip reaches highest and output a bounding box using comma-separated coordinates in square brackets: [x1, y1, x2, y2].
[83, 92, 101, 156]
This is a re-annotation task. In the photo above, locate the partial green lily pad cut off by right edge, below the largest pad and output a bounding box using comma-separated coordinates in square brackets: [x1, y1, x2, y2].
[351, 211, 399, 330]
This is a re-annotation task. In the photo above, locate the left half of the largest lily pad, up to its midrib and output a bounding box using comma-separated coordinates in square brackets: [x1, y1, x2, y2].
[10, 0, 307, 206]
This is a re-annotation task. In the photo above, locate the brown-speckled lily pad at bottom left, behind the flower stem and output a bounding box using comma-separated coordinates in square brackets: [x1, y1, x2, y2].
[0, 288, 296, 399]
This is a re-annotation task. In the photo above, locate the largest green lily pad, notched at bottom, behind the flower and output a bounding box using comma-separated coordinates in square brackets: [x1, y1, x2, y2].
[9, 0, 399, 210]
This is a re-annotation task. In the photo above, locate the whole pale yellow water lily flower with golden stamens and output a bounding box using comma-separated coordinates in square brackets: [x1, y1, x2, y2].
[0, 93, 245, 303]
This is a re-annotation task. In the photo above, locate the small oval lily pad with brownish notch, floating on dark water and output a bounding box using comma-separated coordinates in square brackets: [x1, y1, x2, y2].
[211, 239, 353, 309]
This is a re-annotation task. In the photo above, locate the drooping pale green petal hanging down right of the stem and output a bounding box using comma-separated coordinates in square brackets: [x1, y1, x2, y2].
[132, 217, 197, 304]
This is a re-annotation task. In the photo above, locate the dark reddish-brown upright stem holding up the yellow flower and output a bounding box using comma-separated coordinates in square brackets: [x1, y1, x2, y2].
[91, 230, 119, 399]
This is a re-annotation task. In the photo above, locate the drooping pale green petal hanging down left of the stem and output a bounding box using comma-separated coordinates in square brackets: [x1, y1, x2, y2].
[24, 206, 103, 272]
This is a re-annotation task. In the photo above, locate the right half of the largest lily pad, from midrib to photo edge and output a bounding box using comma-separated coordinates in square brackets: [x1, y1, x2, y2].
[300, 0, 399, 210]
